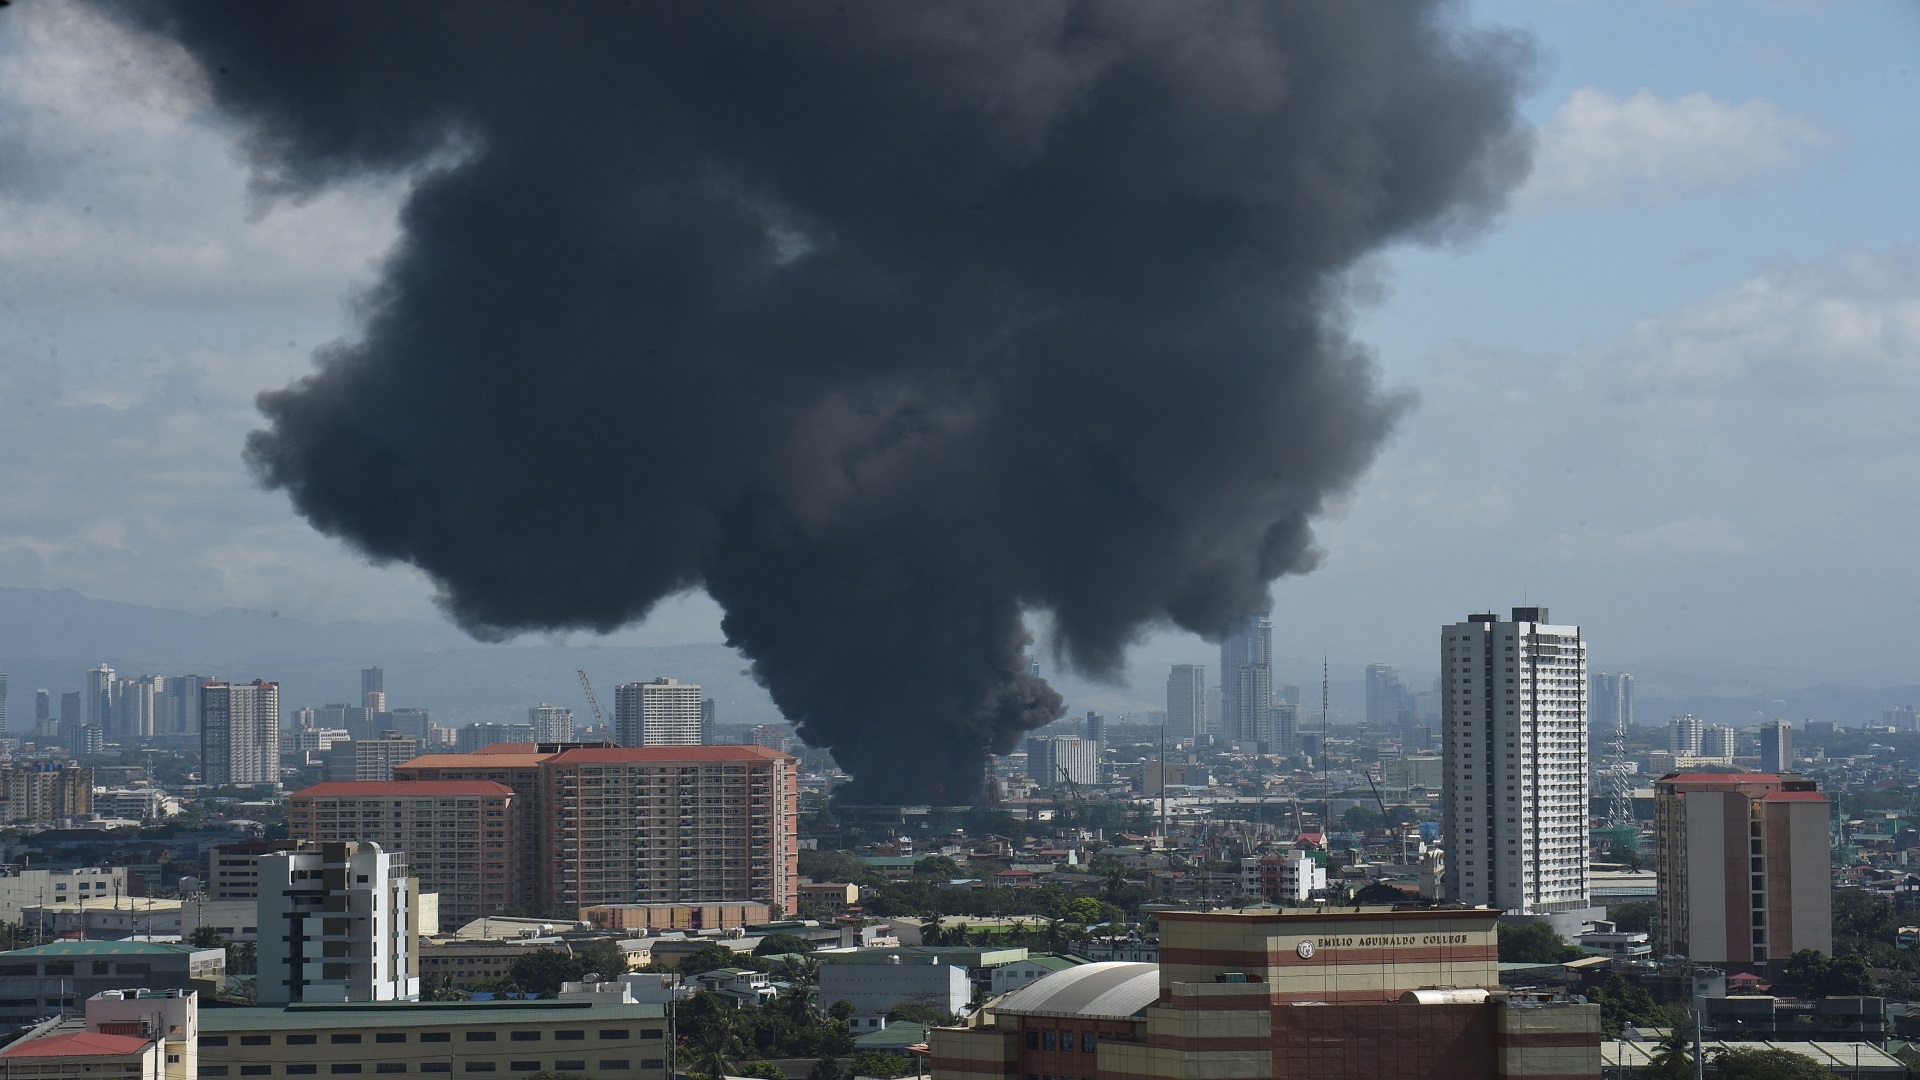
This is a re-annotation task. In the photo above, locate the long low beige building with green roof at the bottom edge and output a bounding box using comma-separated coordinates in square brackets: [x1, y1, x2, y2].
[200, 1001, 672, 1080]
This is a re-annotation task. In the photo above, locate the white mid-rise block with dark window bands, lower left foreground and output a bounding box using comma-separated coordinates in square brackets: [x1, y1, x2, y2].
[253, 842, 420, 1005]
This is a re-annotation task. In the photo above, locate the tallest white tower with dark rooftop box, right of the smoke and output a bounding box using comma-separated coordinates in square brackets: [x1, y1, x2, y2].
[1440, 607, 1588, 915]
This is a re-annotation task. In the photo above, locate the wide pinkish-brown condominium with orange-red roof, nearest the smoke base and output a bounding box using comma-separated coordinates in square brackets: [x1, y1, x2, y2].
[394, 744, 799, 911]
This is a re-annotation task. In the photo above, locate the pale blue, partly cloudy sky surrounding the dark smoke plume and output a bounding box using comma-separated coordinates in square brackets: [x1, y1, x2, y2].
[0, 0, 1920, 698]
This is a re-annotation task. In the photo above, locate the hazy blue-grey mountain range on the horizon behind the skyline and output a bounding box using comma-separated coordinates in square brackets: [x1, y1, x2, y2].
[0, 588, 1920, 730]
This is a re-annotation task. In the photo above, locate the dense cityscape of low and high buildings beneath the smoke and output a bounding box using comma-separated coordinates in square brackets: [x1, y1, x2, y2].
[0, 607, 1920, 1080]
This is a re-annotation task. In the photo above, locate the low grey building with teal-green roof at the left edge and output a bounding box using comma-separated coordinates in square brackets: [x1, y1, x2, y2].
[0, 942, 227, 1028]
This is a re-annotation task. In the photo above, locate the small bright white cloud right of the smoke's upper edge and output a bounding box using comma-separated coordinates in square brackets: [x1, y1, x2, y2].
[1521, 86, 1845, 209]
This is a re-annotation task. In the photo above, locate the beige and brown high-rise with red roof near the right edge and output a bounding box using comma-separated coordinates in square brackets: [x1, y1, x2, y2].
[1653, 773, 1834, 969]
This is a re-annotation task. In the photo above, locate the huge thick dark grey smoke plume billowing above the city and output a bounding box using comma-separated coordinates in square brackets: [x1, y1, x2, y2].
[97, 0, 1526, 801]
